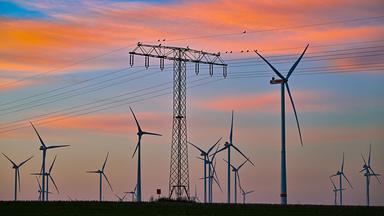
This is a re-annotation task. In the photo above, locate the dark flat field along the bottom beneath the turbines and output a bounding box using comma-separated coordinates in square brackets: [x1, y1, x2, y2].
[0, 202, 384, 216]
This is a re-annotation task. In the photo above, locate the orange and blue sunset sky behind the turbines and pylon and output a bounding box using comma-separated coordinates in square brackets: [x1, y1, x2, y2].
[0, 0, 384, 206]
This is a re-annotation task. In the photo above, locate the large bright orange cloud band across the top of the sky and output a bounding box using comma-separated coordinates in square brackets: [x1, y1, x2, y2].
[0, 0, 384, 89]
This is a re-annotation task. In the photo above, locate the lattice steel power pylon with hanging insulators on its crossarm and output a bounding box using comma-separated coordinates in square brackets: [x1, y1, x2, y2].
[129, 43, 227, 199]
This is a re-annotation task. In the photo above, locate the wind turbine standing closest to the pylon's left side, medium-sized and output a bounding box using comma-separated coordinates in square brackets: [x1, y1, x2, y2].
[129, 107, 161, 202]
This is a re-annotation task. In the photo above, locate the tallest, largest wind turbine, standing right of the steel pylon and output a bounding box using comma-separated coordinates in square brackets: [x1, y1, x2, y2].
[255, 44, 309, 205]
